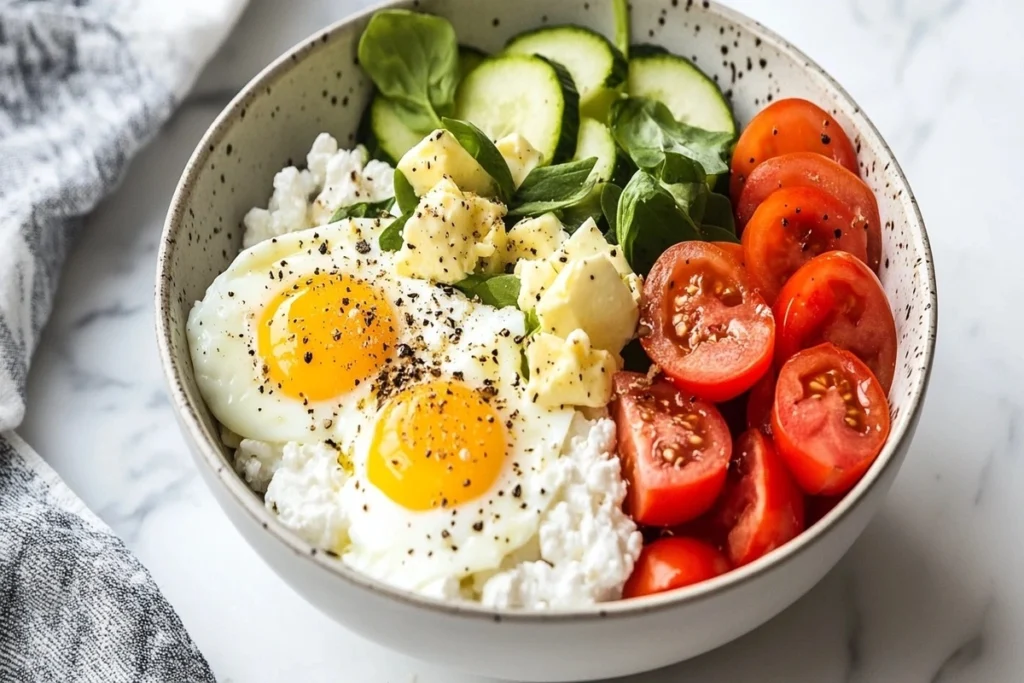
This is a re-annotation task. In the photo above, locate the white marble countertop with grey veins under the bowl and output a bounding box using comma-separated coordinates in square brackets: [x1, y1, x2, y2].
[22, 0, 1024, 683]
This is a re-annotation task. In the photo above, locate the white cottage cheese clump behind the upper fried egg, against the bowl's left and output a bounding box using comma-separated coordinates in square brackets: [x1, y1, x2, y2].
[242, 133, 394, 249]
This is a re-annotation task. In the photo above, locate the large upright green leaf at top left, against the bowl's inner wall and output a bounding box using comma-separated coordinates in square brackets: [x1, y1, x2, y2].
[358, 9, 459, 133]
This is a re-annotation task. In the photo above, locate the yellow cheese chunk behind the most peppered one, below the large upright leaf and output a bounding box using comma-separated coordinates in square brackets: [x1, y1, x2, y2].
[397, 130, 496, 197]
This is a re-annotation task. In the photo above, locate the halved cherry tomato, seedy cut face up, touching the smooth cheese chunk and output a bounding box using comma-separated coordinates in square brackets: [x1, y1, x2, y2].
[640, 242, 775, 401]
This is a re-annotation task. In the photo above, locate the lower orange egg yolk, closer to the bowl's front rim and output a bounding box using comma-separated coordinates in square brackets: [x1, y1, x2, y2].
[367, 380, 506, 510]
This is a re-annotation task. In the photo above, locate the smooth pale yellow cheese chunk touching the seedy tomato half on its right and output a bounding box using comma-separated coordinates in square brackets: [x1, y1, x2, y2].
[536, 253, 639, 353]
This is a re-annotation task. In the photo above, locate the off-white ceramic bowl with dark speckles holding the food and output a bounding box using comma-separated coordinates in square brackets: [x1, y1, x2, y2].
[157, 0, 937, 681]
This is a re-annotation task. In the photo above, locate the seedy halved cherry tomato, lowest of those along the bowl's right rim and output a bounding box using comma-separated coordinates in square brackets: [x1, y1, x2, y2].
[771, 343, 890, 496]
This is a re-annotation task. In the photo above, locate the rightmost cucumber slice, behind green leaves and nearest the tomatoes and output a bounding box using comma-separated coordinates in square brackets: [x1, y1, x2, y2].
[627, 46, 736, 135]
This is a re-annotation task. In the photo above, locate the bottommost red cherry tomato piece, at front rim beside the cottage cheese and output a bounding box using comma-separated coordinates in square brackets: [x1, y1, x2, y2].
[623, 537, 730, 598]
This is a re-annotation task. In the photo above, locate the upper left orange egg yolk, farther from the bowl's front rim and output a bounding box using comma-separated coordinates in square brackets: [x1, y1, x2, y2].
[257, 273, 397, 401]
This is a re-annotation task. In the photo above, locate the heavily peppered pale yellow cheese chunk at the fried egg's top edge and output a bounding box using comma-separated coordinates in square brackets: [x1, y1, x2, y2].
[395, 178, 506, 285]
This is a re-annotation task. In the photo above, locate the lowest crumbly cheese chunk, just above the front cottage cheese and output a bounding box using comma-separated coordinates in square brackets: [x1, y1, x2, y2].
[526, 330, 618, 408]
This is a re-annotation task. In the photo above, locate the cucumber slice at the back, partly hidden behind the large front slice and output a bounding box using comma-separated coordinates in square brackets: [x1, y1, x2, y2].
[505, 26, 629, 120]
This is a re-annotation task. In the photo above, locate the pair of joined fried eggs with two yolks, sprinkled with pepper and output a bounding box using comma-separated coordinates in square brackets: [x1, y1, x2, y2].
[187, 219, 574, 590]
